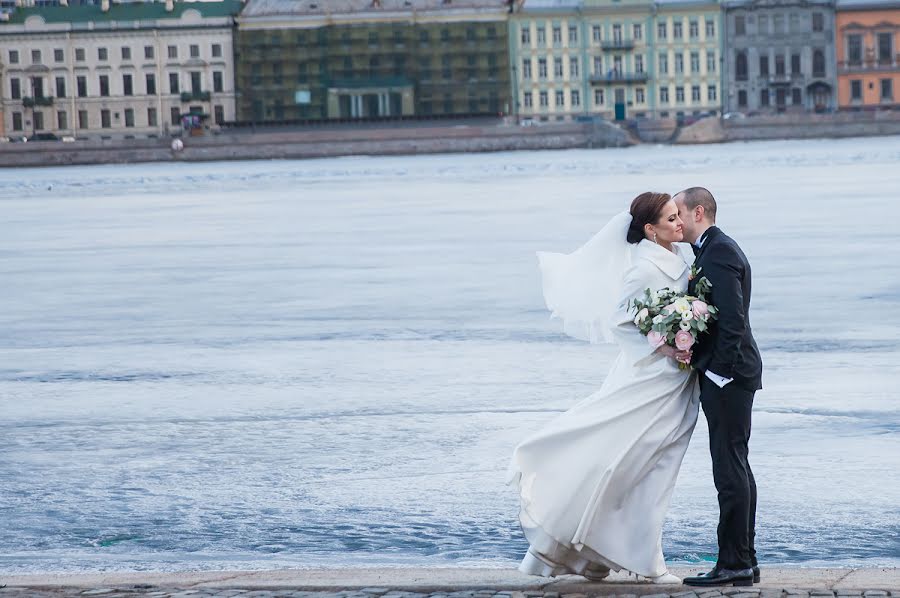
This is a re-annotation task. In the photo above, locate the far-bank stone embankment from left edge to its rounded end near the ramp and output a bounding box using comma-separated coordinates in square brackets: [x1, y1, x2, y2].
[0, 121, 637, 167]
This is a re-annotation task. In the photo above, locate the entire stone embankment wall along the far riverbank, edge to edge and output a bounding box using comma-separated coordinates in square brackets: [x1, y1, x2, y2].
[0, 111, 900, 167]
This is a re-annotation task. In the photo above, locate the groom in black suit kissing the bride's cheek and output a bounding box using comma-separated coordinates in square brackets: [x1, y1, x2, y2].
[673, 187, 762, 586]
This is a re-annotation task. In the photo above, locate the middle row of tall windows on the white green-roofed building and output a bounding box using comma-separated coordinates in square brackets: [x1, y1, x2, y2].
[9, 71, 224, 100]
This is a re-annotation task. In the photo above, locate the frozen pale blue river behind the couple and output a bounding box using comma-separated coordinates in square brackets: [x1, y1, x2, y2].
[0, 137, 900, 573]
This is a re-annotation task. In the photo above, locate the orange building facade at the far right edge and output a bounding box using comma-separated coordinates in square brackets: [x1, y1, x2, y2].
[835, 0, 900, 110]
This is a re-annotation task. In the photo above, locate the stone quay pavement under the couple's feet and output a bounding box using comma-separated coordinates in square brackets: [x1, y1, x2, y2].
[0, 568, 900, 598]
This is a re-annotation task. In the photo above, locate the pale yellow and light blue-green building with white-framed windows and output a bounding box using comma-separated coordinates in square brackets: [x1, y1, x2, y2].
[510, 0, 722, 120]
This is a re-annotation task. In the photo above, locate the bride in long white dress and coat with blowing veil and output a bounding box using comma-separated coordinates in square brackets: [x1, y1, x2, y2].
[510, 192, 698, 584]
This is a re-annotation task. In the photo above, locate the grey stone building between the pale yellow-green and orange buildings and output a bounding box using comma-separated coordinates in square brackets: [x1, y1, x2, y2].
[725, 0, 837, 113]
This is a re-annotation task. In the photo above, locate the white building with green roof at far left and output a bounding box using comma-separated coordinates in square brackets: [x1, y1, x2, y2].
[0, 1, 240, 138]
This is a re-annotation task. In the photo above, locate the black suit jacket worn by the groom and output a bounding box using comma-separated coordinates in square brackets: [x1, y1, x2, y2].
[688, 226, 762, 390]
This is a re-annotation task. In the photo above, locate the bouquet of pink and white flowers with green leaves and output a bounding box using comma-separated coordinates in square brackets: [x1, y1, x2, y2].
[630, 273, 718, 370]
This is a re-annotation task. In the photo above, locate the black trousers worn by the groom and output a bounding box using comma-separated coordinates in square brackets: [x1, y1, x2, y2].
[700, 374, 757, 569]
